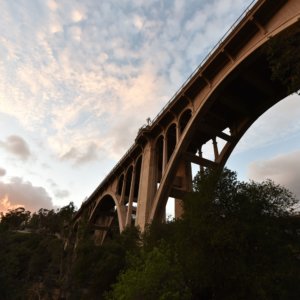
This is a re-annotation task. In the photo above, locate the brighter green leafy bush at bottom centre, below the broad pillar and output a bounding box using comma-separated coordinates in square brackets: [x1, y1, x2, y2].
[107, 242, 191, 300]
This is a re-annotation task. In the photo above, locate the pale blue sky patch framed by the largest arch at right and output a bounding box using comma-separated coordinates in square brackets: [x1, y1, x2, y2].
[226, 94, 300, 199]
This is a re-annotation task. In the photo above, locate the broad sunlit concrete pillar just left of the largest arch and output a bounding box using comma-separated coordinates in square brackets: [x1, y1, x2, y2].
[135, 141, 156, 231]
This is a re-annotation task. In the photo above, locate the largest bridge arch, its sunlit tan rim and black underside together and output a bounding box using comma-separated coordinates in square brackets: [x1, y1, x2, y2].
[147, 19, 298, 223]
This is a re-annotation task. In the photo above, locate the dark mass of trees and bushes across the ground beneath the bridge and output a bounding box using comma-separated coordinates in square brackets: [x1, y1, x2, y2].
[0, 175, 300, 300]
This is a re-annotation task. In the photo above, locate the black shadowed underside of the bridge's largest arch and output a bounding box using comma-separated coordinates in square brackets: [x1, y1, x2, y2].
[154, 48, 287, 223]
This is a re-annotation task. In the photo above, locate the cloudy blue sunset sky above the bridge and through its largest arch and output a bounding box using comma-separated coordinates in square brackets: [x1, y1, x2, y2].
[0, 0, 300, 216]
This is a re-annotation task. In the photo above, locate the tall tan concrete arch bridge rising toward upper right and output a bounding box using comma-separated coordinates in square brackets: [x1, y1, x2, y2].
[72, 0, 300, 244]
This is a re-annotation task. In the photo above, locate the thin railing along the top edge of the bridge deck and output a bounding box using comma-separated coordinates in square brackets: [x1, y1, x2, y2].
[85, 0, 259, 206]
